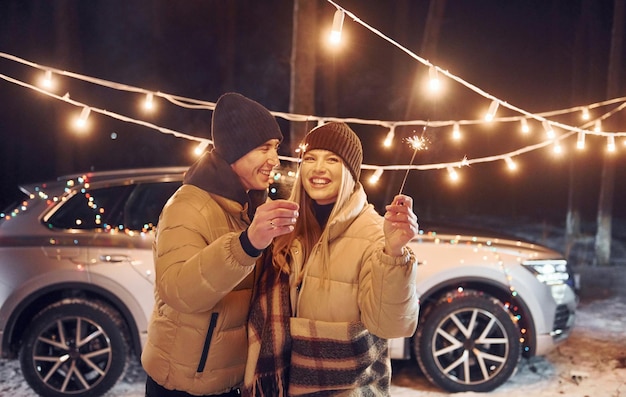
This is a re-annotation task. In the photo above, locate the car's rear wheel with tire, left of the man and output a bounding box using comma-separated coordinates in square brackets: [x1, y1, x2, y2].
[20, 299, 128, 397]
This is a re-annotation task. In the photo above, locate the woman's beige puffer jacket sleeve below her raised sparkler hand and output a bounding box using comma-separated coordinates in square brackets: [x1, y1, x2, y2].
[359, 238, 419, 339]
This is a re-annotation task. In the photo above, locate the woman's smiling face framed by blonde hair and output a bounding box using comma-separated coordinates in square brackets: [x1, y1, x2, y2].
[300, 149, 343, 205]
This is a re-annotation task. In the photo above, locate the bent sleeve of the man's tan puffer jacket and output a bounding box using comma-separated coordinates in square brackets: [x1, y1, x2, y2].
[154, 189, 257, 313]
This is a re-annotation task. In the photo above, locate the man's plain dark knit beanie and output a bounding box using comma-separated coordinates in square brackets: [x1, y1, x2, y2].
[211, 92, 283, 164]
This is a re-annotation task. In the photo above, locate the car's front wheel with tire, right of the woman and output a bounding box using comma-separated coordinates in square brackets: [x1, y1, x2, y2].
[413, 291, 522, 392]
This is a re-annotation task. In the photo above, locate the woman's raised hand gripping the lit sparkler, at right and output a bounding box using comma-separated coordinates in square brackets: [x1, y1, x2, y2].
[383, 194, 419, 256]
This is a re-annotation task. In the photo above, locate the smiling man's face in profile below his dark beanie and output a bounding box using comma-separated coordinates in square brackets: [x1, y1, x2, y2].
[230, 139, 280, 191]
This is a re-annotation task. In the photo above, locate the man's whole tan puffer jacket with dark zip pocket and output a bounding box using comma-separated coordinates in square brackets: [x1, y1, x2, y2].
[142, 156, 257, 395]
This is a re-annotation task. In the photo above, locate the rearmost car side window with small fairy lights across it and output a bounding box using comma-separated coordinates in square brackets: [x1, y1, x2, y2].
[46, 186, 132, 230]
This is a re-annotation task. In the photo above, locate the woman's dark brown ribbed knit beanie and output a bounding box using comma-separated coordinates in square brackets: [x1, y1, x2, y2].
[303, 121, 363, 182]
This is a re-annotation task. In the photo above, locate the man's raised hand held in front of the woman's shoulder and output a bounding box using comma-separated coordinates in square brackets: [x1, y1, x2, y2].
[248, 200, 299, 250]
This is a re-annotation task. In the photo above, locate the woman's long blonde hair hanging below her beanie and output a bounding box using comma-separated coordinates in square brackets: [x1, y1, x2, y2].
[272, 161, 357, 282]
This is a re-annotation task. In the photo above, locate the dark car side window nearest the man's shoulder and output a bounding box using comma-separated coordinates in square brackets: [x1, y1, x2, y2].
[124, 182, 180, 231]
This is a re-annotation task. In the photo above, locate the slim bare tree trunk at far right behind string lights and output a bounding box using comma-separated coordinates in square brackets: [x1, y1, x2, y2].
[595, 0, 626, 266]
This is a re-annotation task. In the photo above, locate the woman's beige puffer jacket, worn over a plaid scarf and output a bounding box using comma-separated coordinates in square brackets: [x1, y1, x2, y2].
[290, 185, 419, 339]
